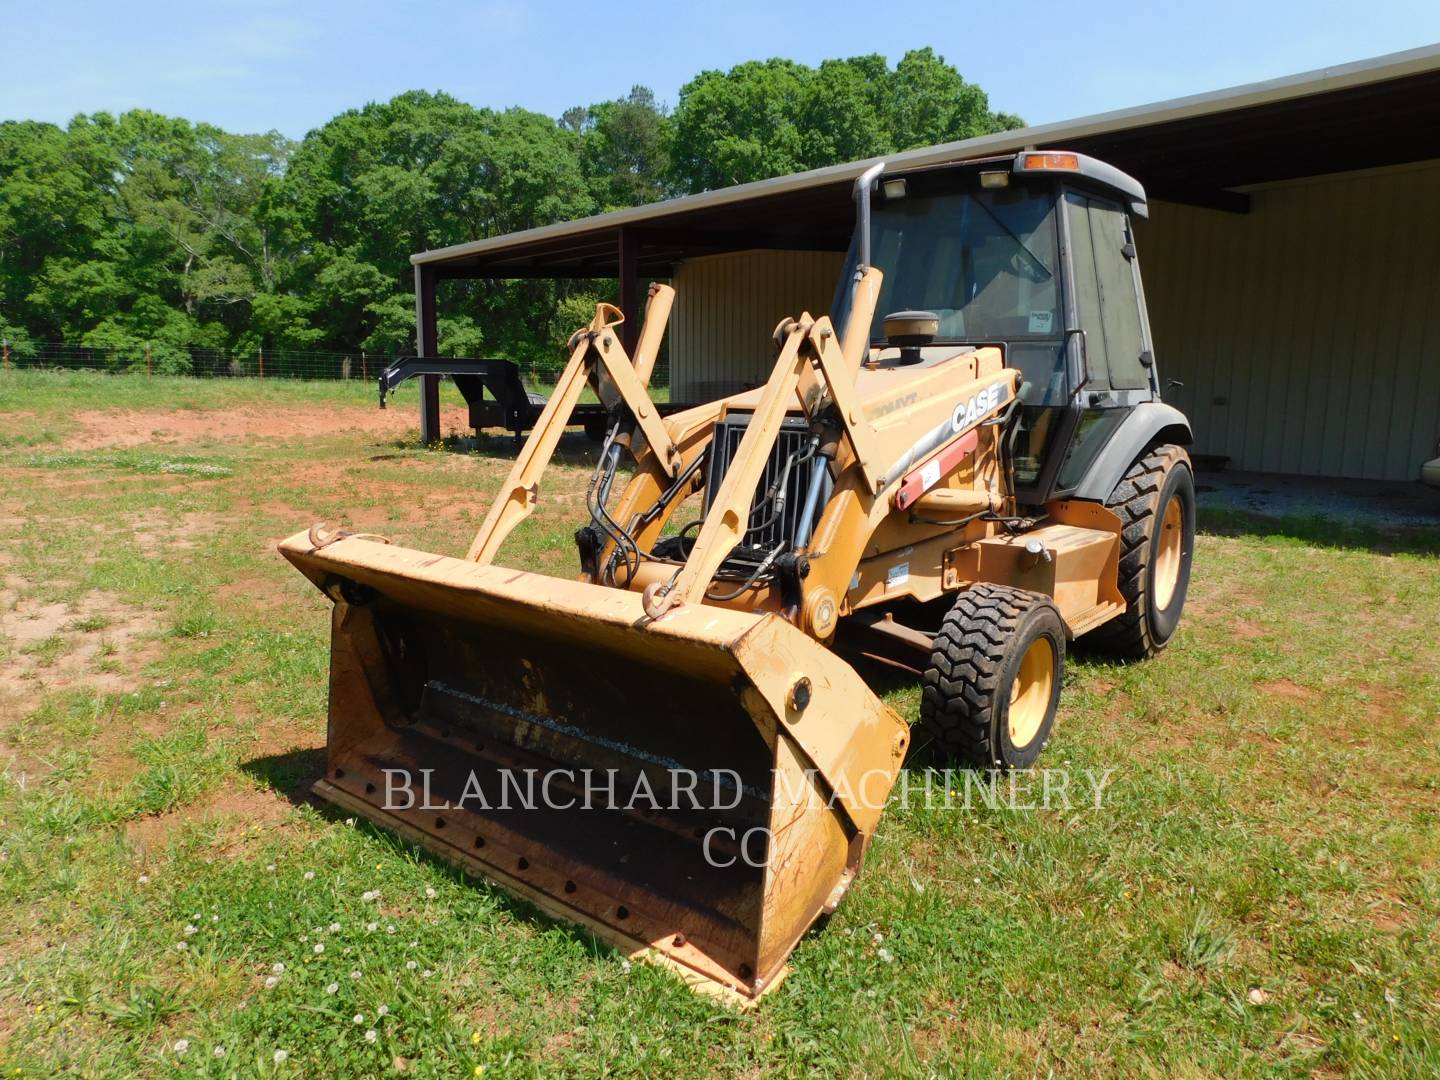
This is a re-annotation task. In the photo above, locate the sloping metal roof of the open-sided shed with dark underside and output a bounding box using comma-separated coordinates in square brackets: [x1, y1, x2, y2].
[410, 45, 1440, 278]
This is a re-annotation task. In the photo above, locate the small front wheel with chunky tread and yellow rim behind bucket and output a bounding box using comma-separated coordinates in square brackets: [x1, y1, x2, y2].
[920, 585, 1066, 769]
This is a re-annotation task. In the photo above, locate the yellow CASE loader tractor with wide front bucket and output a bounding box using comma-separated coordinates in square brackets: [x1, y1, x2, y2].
[281, 151, 1195, 1001]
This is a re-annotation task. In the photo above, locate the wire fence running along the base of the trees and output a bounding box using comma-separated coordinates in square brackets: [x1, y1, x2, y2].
[0, 341, 393, 380]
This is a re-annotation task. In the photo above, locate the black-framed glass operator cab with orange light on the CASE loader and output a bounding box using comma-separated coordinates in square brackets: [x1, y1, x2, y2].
[832, 151, 1159, 505]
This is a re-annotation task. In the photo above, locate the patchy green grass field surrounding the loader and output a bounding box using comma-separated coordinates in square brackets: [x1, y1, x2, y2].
[0, 374, 1440, 1077]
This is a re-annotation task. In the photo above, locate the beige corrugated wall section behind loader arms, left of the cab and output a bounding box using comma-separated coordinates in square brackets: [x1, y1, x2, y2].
[670, 251, 844, 402]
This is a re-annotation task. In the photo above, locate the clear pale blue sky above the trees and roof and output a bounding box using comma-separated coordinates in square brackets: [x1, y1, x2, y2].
[0, 0, 1440, 137]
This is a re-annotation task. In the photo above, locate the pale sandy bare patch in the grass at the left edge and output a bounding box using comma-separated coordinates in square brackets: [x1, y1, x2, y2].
[0, 577, 160, 702]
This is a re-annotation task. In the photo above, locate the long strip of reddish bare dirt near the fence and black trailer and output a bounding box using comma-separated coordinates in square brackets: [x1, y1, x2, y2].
[63, 405, 469, 449]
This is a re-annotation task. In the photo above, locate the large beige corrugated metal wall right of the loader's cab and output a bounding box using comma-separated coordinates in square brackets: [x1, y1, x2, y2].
[1136, 161, 1440, 480]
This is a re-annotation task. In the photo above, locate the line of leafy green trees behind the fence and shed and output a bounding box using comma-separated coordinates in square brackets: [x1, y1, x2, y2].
[0, 49, 1021, 372]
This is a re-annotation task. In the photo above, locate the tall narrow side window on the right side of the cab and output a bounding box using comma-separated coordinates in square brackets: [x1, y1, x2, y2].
[1066, 192, 1149, 390]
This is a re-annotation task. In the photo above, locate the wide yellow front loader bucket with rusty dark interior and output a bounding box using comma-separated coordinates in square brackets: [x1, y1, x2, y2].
[281, 533, 909, 999]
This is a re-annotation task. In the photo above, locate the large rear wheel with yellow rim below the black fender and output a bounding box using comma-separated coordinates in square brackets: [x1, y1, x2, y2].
[1086, 444, 1195, 660]
